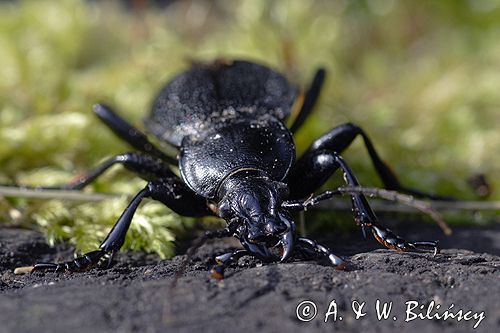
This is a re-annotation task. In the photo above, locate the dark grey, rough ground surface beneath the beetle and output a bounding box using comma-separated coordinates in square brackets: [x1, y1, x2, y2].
[0, 220, 500, 333]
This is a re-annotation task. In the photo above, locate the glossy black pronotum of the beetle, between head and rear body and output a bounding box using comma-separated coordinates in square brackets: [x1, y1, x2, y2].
[179, 115, 295, 199]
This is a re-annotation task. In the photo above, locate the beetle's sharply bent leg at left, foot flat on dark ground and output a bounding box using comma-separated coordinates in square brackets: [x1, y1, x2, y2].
[33, 177, 211, 272]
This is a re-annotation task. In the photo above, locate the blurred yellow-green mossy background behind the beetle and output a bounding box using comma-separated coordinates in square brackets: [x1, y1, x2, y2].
[0, 0, 500, 257]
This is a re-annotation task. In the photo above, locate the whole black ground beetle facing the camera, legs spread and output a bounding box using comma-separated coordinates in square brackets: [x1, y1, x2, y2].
[33, 60, 437, 277]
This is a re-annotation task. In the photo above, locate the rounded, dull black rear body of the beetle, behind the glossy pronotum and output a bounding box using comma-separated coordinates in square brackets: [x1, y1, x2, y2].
[145, 61, 298, 147]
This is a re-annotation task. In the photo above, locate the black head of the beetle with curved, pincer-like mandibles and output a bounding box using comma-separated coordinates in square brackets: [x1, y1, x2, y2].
[218, 171, 295, 261]
